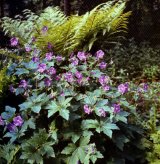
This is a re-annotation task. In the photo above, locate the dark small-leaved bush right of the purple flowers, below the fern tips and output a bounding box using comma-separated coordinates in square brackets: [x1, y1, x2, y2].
[106, 39, 160, 83]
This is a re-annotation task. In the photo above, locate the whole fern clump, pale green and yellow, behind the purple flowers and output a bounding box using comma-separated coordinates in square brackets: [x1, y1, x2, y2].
[2, 1, 130, 55]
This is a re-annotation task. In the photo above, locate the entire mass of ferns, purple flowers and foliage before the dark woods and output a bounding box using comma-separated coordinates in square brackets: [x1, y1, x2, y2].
[0, 2, 160, 164]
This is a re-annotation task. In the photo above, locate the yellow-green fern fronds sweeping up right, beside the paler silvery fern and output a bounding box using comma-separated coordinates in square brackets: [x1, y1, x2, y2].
[34, 1, 131, 54]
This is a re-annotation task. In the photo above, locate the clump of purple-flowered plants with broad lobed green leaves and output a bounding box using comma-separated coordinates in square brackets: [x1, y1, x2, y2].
[0, 43, 142, 164]
